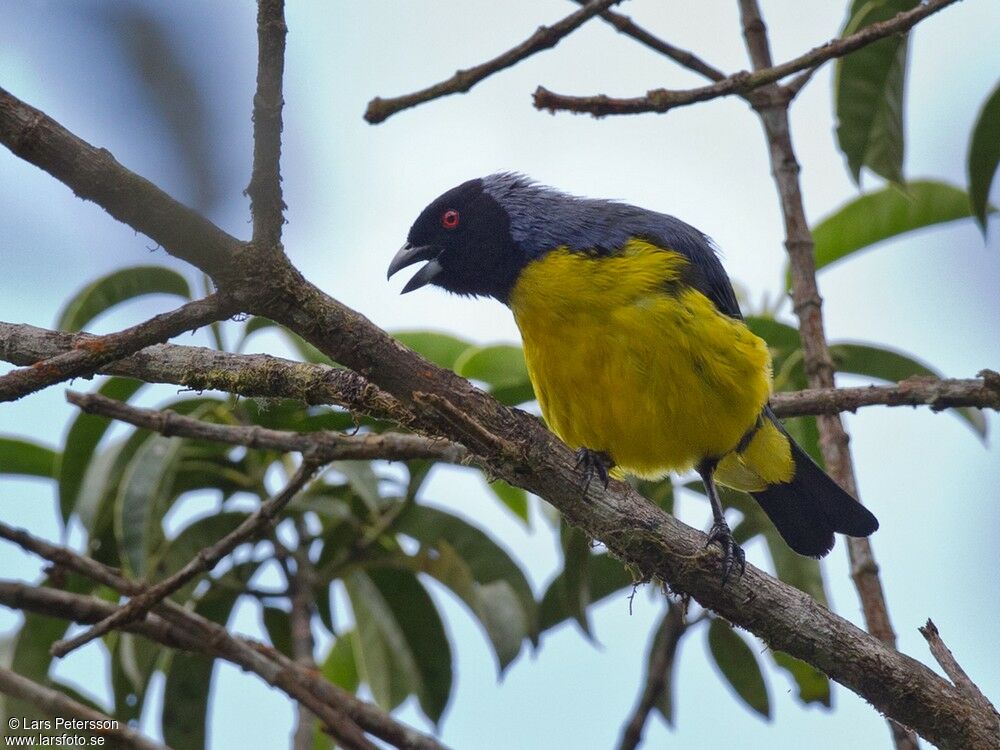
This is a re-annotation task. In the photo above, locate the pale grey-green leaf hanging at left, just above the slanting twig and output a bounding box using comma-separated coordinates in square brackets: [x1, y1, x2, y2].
[115, 435, 184, 578]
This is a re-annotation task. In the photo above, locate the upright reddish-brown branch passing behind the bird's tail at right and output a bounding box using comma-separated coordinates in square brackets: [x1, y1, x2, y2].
[739, 0, 920, 750]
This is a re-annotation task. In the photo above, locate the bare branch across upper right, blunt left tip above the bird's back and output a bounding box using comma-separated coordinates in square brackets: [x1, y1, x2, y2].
[534, 0, 958, 117]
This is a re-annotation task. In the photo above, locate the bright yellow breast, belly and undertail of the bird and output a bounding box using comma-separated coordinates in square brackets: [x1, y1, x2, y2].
[510, 240, 793, 489]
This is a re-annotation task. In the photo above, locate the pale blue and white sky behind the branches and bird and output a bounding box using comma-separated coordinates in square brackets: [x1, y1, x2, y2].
[0, 0, 1000, 750]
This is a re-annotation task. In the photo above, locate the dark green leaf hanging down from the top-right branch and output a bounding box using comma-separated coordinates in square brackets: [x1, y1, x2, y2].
[834, 0, 918, 182]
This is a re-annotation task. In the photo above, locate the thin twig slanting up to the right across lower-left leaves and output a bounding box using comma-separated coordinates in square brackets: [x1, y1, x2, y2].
[51, 455, 319, 657]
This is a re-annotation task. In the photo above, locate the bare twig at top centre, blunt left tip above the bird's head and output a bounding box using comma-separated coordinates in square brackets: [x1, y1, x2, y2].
[365, 0, 622, 125]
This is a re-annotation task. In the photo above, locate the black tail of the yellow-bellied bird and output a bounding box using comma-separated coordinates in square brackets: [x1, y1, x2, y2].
[750, 418, 878, 557]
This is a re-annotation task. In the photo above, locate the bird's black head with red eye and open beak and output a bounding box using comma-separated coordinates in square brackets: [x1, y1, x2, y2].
[388, 179, 528, 303]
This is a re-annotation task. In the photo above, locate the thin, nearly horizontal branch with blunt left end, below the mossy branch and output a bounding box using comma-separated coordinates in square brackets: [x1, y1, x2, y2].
[66, 391, 468, 463]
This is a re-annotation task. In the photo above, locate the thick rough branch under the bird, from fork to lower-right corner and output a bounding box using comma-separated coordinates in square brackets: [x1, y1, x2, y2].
[0, 76, 995, 748]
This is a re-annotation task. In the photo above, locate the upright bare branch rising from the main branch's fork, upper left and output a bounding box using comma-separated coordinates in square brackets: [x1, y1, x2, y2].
[245, 0, 288, 252]
